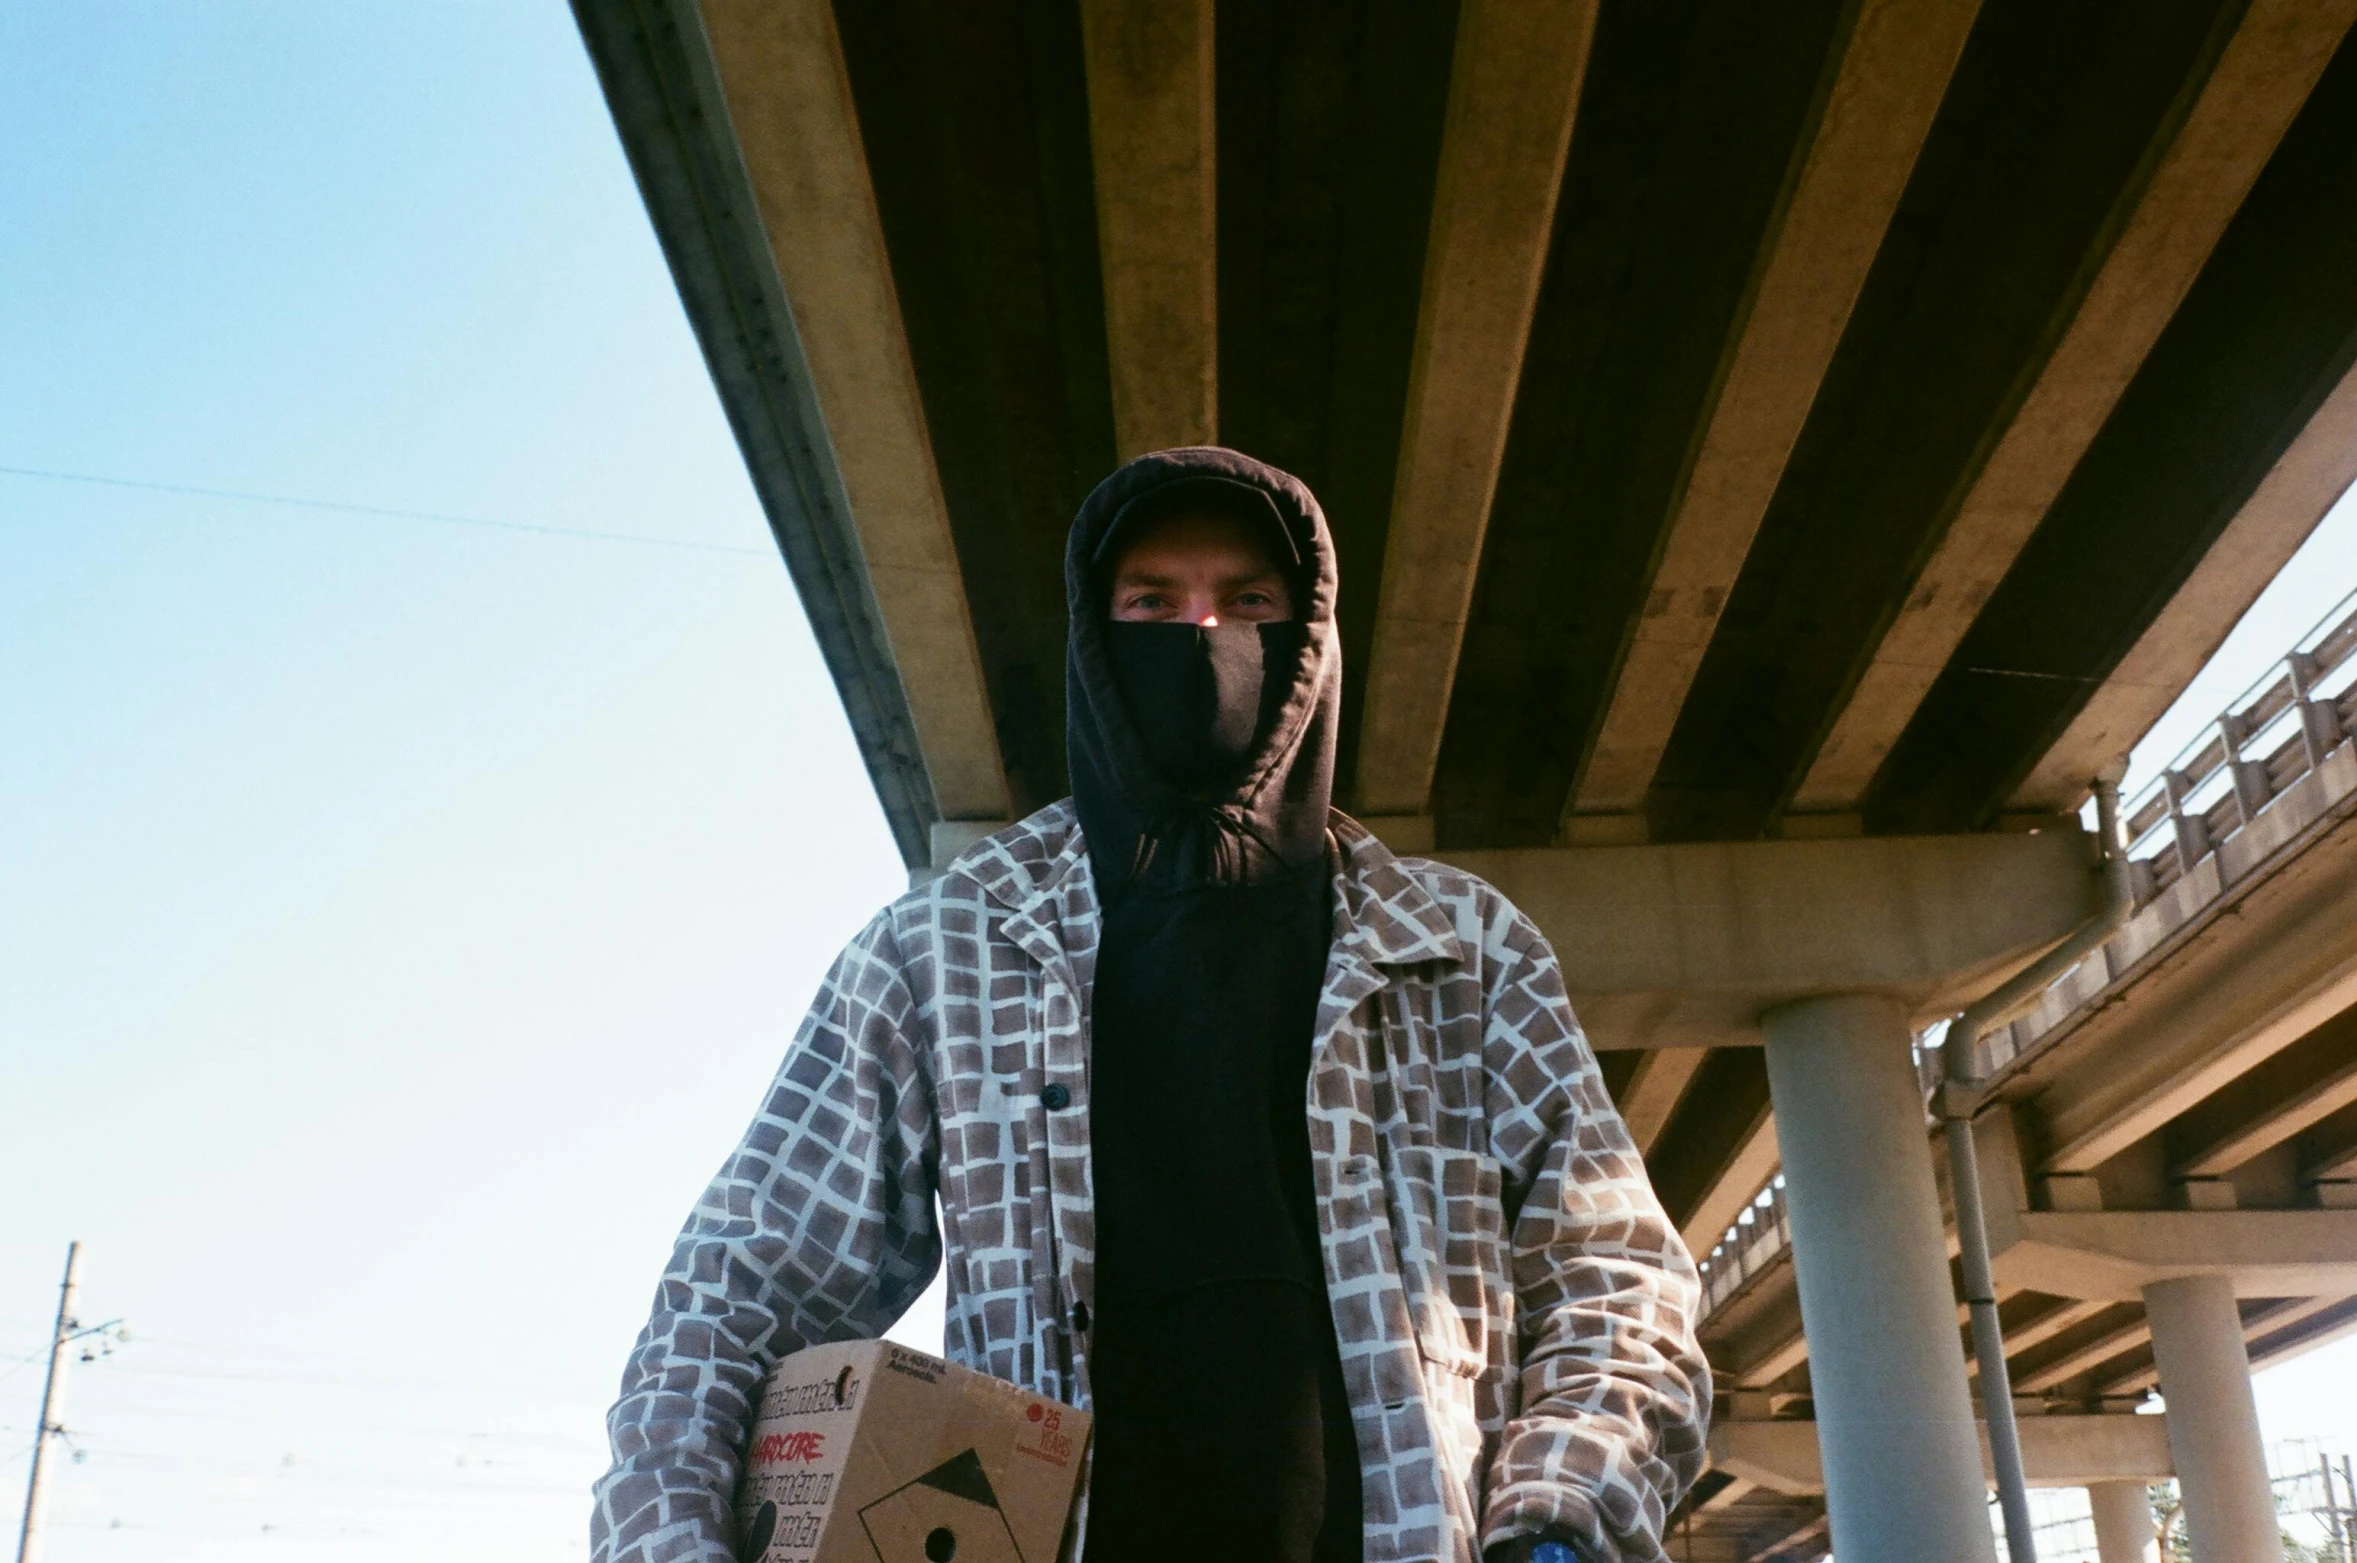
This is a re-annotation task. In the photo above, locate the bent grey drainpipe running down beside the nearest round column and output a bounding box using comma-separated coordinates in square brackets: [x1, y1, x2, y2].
[1940, 759, 2135, 1563]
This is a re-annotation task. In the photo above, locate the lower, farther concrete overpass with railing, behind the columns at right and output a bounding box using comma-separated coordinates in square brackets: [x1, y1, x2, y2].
[1697, 599, 2357, 1563]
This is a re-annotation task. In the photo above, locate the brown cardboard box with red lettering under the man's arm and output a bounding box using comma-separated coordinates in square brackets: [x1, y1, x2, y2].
[738, 1341, 1089, 1563]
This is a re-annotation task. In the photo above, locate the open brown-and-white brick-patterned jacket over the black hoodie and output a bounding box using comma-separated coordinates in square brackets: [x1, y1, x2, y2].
[592, 804, 1711, 1563]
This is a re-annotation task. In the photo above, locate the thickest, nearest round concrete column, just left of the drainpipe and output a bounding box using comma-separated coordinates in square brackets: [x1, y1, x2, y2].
[1761, 995, 1996, 1563]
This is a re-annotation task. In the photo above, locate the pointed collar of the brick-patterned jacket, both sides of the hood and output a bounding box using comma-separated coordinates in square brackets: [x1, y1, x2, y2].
[950, 799, 1466, 967]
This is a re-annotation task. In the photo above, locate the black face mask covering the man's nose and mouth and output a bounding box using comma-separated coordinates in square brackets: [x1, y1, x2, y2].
[1105, 622, 1306, 799]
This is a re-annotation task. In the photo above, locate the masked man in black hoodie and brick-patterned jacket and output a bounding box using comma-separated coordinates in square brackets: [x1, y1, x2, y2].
[592, 448, 1709, 1563]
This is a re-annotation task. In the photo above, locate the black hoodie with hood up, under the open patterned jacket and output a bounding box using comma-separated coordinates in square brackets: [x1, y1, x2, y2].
[1065, 448, 1360, 1563]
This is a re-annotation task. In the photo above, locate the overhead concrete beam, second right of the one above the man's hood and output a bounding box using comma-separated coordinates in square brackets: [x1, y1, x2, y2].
[1572, 0, 1980, 813]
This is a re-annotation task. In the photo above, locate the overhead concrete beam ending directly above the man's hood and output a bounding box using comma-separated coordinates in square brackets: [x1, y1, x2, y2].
[1080, 0, 1219, 460]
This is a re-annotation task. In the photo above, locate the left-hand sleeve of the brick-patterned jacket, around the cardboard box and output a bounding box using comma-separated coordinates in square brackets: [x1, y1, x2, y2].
[589, 912, 940, 1563]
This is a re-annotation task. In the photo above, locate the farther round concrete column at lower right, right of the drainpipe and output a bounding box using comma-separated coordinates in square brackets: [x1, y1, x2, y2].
[2145, 1275, 2284, 1563]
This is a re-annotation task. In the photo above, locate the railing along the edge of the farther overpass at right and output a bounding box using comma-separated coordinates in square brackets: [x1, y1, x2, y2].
[1699, 579, 2357, 1315]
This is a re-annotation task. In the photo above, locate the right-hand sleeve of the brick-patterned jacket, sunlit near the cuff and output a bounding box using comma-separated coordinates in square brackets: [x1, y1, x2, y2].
[1483, 905, 1711, 1563]
